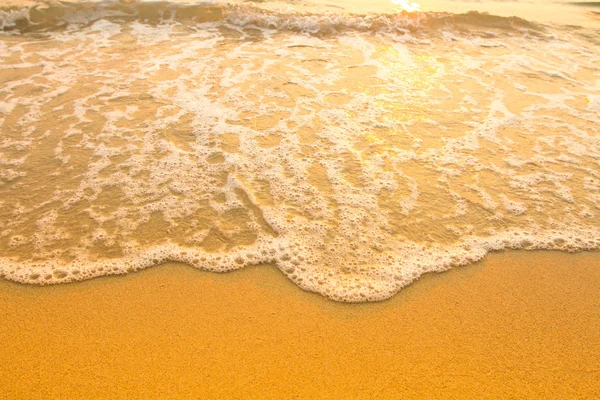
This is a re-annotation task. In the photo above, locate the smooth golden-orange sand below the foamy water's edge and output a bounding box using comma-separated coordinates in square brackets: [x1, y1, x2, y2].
[0, 252, 600, 399]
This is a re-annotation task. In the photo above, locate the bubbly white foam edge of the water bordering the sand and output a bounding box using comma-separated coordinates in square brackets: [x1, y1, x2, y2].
[0, 228, 600, 303]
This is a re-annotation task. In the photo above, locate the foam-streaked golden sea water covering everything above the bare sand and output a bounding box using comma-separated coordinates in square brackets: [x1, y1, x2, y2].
[0, 1, 600, 301]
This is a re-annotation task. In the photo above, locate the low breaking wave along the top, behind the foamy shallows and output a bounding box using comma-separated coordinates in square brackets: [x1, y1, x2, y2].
[0, 0, 545, 35]
